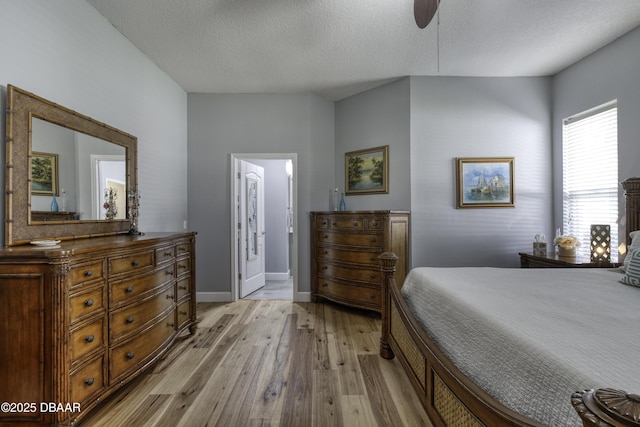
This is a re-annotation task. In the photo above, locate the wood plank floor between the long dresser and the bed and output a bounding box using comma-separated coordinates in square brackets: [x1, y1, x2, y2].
[82, 300, 431, 427]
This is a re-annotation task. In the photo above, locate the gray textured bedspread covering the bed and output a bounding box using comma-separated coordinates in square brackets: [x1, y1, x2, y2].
[402, 267, 640, 427]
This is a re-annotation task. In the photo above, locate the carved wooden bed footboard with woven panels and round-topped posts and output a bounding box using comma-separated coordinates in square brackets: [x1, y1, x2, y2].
[379, 252, 640, 427]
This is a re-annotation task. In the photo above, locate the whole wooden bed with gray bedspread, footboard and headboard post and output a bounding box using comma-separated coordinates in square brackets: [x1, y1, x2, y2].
[380, 178, 640, 427]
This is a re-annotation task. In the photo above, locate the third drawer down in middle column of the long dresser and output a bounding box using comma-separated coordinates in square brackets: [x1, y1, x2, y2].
[109, 285, 175, 341]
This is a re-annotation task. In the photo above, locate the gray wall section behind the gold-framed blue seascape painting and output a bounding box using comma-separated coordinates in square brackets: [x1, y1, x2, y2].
[411, 77, 553, 267]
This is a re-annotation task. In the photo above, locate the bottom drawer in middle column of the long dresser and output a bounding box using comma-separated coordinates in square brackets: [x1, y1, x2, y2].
[109, 311, 175, 382]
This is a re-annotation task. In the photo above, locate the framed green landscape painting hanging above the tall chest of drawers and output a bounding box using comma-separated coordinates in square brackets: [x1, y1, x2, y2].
[344, 145, 389, 195]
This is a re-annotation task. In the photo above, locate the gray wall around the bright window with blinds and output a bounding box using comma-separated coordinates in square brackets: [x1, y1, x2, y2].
[553, 28, 640, 247]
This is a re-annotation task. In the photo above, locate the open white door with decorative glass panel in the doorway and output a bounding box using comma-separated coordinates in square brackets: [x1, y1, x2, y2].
[238, 160, 265, 298]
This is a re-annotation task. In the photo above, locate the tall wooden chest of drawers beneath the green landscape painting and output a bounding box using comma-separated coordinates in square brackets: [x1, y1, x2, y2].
[311, 211, 409, 312]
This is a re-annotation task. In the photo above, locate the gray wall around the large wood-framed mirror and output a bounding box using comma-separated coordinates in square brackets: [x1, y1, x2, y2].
[0, 0, 187, 242]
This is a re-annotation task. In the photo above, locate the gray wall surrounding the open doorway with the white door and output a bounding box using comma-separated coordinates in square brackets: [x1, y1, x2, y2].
[187, 93, 335, 300]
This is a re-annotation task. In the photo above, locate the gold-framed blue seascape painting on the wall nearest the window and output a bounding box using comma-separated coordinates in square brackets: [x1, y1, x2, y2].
[456, 157, 515, 209]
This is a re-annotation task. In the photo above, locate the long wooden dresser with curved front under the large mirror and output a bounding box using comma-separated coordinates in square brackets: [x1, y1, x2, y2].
[0, 233, 196, 426]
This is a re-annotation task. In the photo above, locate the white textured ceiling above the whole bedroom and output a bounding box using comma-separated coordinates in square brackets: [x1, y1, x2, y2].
[87, 0, 640, 100]
